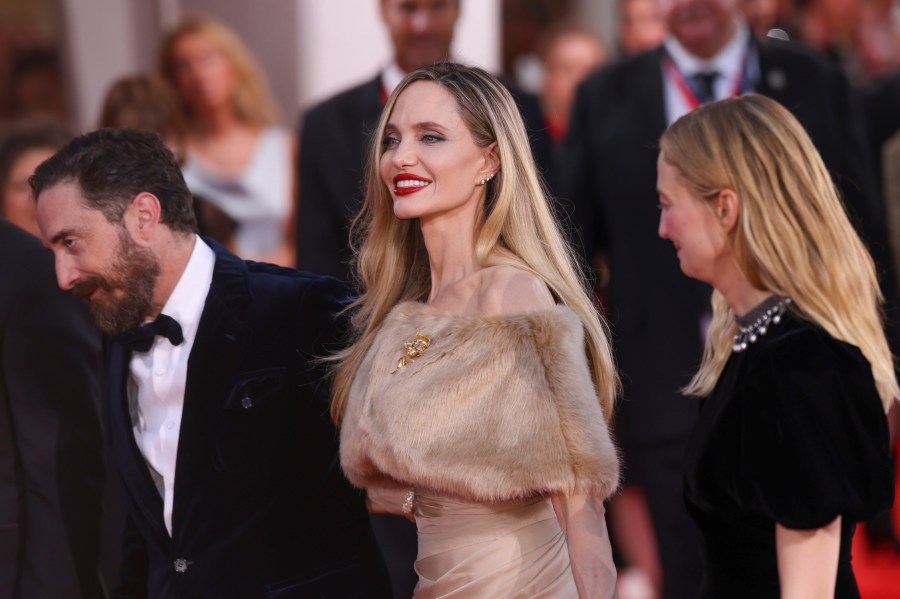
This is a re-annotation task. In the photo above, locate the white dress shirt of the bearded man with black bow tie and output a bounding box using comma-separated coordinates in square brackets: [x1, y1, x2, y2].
[128, 237, 216, 536]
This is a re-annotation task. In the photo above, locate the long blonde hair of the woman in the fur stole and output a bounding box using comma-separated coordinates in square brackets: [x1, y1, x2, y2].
[331, 63, 619, 424]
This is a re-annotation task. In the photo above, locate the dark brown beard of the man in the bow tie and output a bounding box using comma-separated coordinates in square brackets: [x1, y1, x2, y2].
[72, 230, 159, 335]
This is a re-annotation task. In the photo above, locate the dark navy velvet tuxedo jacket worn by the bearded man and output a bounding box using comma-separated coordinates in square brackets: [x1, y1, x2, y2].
[107, 240, 385, 599]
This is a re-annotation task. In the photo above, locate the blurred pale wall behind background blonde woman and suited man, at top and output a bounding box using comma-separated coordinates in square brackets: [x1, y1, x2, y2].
[60, 0, 506, 130]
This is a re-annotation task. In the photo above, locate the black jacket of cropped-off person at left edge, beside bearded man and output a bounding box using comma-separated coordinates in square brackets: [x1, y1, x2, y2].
[0, 218, 105, 599]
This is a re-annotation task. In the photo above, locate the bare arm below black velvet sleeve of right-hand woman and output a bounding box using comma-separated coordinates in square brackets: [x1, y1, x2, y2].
[775, 516, 841, 599]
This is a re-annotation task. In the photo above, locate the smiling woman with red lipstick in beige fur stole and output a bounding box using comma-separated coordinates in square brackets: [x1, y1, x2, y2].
[332, 64, 618, 597]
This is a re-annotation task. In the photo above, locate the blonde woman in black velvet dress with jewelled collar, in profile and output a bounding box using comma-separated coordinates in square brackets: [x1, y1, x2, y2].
[658, 95, 898, 599]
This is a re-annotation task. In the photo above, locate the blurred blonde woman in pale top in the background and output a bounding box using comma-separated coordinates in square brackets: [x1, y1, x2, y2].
[159, 17, 296, 266]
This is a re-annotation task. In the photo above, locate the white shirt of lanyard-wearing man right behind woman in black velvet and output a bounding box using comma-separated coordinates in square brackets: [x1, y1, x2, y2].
[663, 23, 759, 125]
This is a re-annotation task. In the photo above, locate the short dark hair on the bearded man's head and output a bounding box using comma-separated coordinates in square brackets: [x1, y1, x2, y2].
[30, 129, 197, 233]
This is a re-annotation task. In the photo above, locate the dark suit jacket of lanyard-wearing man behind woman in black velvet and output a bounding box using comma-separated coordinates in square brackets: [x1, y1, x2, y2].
[560, 41, 888, 446]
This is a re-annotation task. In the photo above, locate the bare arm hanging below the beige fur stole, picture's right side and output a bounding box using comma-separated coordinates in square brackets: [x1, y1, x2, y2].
[550, 495, 617, 598]
